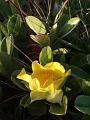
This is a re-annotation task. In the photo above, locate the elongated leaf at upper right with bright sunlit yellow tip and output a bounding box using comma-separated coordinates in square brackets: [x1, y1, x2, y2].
[57, 17, 80, 38]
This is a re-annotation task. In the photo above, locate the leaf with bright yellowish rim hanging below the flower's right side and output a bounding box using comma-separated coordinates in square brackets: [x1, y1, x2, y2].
[49, 96, 67, 115]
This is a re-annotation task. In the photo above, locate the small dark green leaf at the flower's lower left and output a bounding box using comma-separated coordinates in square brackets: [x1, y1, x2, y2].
[20, 94, 31, 108]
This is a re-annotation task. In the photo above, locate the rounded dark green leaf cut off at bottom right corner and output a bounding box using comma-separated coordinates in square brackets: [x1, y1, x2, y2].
[75, 95, 90, 115]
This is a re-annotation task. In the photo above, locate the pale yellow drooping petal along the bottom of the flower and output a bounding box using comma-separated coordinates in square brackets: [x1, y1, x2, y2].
[30, 85, 63, 104]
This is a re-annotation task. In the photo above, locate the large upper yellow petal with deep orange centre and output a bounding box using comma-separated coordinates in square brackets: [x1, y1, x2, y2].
[32, 61, 65, 86]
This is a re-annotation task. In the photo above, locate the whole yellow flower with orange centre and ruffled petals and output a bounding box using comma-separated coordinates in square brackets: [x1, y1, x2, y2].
[17, 61, 70, 104]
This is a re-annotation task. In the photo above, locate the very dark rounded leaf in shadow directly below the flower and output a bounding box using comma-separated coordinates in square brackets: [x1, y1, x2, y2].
[27, 100, 47, 116]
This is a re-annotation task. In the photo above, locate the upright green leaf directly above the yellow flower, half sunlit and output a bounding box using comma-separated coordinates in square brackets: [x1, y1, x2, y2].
[39, 46, 53, 65]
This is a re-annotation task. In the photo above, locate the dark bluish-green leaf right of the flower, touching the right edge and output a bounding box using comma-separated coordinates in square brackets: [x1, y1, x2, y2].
[70, 65, 90, 81]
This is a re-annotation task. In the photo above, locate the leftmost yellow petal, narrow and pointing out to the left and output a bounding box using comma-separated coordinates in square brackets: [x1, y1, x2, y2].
[17, 68, 31, 83]
